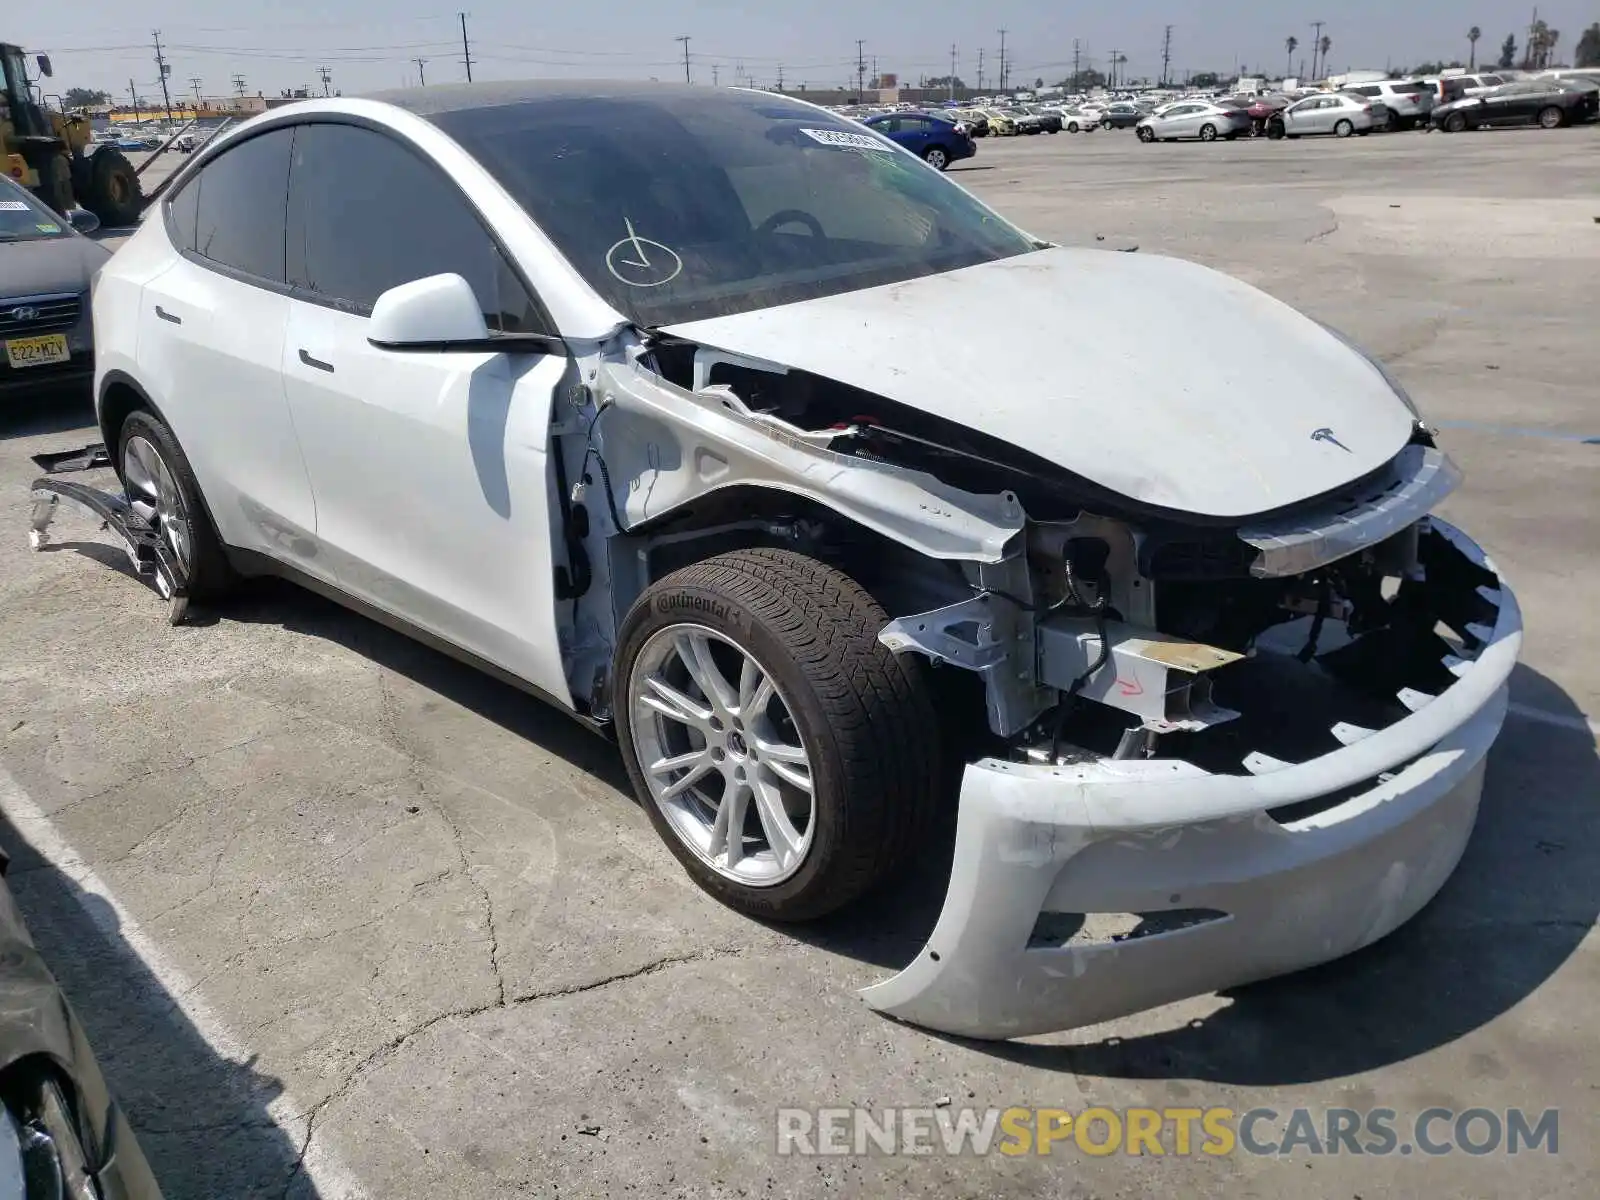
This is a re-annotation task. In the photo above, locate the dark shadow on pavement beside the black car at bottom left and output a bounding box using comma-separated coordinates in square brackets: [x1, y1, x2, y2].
[0, 814, 318, 1200]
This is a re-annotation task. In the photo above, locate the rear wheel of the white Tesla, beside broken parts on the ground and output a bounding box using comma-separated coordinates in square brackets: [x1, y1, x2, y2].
[117, 410, 235, 600]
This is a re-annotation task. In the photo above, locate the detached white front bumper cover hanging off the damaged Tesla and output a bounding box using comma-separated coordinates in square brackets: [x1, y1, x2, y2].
[862, 520, 1522, 1038]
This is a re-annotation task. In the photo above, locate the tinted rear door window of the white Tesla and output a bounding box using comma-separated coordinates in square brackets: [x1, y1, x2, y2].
[194, 130, 294, 283]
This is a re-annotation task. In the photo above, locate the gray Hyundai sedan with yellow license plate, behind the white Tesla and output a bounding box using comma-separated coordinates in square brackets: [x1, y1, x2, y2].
[0, 176, 110, 397]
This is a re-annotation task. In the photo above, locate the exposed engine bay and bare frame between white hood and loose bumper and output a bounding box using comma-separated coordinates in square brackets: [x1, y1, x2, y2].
[568, 336, 1490, 793]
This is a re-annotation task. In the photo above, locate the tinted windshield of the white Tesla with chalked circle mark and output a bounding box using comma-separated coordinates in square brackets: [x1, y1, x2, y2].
[429, 90, 1034, 326]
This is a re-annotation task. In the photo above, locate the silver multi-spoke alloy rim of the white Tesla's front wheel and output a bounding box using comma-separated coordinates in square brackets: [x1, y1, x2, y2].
[627, 624, 816, 888]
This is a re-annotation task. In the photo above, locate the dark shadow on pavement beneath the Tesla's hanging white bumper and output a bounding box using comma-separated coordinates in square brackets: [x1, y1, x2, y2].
[812, 666, 1600, 1086]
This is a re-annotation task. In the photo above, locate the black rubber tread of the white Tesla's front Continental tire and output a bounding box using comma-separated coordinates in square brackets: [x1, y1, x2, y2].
[618, 549, 941, 920]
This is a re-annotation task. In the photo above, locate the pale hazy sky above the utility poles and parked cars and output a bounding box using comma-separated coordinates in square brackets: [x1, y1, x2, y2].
[9, 0, 1600, 99]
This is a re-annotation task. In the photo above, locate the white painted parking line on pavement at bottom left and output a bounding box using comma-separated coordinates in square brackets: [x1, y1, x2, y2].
[0, 766, 366, 1200]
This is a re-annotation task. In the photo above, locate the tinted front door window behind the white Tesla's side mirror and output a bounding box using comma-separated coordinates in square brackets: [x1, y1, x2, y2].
[288, 125, 547, 333]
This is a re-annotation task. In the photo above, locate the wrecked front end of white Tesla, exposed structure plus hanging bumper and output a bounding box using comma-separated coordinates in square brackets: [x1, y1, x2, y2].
[557, 326, 1522, 1038]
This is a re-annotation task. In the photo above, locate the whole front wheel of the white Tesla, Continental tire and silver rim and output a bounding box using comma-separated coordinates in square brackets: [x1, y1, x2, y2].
[613, 549, 941, 920]
